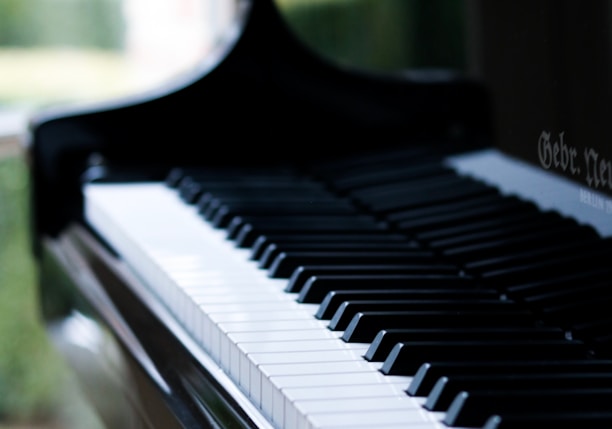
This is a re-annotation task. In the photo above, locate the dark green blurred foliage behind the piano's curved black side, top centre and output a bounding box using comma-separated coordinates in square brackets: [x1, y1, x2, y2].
[276, 0, 465, 71]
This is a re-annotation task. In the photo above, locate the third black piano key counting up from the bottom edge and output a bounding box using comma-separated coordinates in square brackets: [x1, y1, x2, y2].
[423, 373, 612, 411]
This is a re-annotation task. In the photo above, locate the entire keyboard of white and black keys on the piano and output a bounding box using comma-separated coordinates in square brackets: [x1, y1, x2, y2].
[84, 147, 612, 429]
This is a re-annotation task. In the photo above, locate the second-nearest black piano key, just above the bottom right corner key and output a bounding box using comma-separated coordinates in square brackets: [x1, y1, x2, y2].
[443, 388, 612, 427]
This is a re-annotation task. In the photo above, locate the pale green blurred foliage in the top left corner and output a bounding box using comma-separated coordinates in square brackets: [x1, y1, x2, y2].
[0, 0, 123, 49]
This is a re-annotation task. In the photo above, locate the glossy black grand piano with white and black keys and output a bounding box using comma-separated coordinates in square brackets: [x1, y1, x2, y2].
[28, 0, 612, 429]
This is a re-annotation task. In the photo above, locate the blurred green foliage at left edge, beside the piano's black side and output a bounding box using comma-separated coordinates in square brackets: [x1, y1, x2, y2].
[0, 157, 66, 422]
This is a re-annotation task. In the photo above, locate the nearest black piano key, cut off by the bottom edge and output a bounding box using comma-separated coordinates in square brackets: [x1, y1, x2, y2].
[482, 410, 612, 429]
